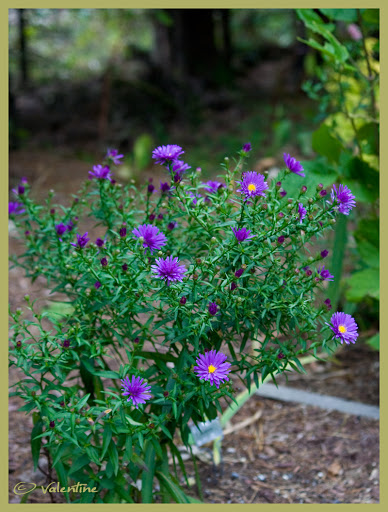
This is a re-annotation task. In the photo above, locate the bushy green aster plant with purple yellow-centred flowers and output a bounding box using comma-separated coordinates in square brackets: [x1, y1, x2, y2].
[9, 144, 358, 503]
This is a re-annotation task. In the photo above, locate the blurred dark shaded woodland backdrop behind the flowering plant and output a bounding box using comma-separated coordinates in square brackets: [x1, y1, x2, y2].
[10, 9, 316, 177]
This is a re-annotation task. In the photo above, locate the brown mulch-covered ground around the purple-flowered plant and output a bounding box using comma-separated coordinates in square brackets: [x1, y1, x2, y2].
[9, 149, 379, 503]
